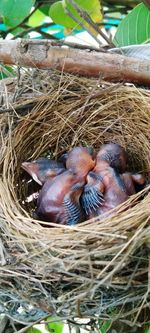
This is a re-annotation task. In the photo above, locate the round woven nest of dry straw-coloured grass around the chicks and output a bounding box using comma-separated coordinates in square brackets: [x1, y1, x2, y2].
[0, 70, 150, 322]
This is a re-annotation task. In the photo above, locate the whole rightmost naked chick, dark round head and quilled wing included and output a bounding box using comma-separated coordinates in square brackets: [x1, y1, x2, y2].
[81, 143, 145, 218]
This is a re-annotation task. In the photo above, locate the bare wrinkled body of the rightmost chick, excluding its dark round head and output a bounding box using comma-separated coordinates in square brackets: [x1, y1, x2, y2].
[81, 161, 145, 218]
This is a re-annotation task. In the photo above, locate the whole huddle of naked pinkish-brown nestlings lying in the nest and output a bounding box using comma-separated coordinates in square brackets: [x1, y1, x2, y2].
[22, 143, 146, 225]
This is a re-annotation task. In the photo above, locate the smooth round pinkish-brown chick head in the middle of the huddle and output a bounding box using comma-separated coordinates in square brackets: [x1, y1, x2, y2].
[66, 147, 95, 180]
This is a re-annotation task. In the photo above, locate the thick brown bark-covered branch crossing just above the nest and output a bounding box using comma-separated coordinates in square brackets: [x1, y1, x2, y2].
[0, 39, 150, 86]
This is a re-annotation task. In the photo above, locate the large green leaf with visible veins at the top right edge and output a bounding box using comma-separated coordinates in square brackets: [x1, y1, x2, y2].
[113, 3, 150, 46]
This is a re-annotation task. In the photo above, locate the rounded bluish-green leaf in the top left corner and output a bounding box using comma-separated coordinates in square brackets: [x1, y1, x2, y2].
[0, 0, 35, 27]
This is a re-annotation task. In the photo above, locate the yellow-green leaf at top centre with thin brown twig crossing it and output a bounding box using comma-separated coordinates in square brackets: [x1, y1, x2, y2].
[49, 0, 102, 30]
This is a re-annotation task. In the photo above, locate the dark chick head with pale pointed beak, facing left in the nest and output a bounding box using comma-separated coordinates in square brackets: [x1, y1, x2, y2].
[21, 157, 66, 185]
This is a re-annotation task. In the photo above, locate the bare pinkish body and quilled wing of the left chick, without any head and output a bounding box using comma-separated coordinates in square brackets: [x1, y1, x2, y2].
[35, 171, 84, 225]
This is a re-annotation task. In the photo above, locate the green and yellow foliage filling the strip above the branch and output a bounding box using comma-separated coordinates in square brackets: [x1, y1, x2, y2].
[0, 0, 150, 46]
